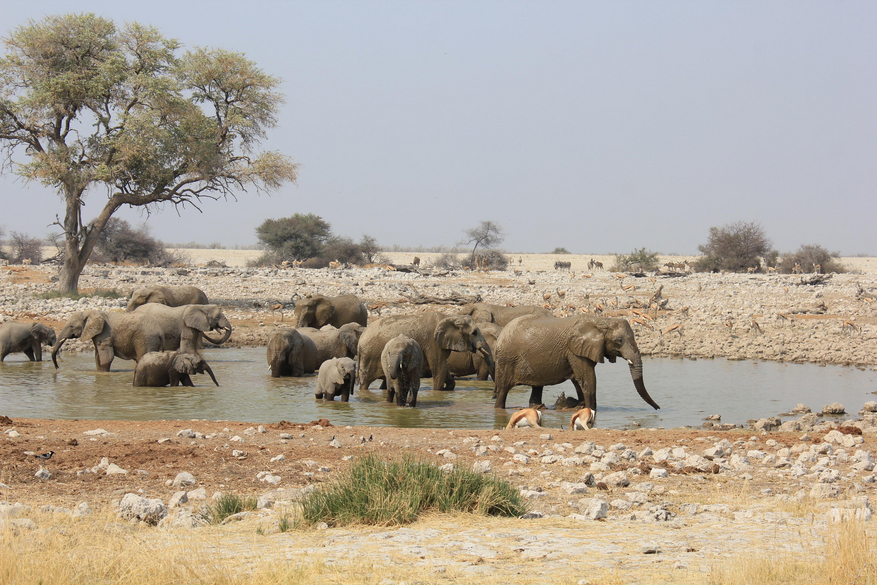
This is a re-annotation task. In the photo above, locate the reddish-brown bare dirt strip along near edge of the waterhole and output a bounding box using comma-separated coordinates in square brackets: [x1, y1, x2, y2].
[0, 417, 877, 514]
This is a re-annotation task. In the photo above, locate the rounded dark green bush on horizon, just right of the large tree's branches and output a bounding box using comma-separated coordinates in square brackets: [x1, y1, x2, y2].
[256, 213, 332, 263]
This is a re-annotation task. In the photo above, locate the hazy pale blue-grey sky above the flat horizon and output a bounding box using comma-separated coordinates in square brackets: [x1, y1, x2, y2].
[0, 0, 877, 255]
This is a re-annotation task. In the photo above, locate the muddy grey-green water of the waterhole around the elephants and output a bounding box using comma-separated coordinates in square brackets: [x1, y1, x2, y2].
[0, 348, 877, 428]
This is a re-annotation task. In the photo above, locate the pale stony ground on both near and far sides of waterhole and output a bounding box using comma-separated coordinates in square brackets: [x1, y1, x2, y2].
[0, 255, 877, 583]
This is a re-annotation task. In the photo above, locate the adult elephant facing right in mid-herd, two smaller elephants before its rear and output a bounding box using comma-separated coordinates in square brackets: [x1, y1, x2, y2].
[358, 312, 493, 390]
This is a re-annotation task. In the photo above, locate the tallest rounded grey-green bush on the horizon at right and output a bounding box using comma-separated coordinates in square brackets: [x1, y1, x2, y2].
[695, 221, 771, 272]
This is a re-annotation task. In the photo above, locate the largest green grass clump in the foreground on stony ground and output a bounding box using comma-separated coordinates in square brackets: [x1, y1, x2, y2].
[301, 455, 527, 526]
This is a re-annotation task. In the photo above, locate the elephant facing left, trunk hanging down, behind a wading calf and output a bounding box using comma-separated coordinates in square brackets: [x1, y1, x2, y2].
[52, 305, 166, 372]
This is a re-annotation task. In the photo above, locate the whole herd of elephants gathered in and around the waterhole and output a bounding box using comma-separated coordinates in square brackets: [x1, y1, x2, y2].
[0, 286, 659, 412]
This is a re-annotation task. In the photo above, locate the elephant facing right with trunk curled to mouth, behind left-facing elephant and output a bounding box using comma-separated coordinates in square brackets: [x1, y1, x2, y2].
[133, 303, 232, 353]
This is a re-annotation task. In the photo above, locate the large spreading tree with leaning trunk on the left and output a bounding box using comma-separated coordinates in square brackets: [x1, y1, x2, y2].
[0, 14, 298, 293]
